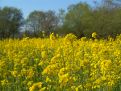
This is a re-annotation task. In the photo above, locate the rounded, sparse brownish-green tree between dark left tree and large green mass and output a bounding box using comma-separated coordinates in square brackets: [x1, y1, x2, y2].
[27, 11, 58, 37]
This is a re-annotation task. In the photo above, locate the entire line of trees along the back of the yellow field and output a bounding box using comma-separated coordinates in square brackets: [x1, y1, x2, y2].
[0, 0, 121, 39]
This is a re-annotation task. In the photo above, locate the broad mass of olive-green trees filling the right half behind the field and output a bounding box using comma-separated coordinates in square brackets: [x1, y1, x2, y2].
[61, 3, 121, 38]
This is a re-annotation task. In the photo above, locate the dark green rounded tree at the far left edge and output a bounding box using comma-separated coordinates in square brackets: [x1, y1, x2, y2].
[0, 7, 23, 38]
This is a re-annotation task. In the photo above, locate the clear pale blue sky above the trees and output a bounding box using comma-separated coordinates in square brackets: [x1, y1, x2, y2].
[0, 0, 94, 18]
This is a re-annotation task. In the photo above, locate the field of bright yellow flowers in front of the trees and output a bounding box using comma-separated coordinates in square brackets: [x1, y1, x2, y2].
[0, 33, 121, 91]
